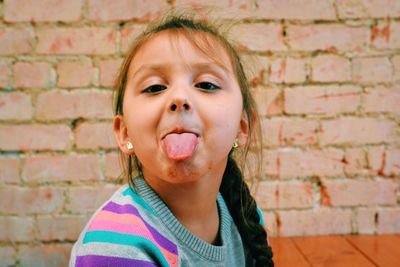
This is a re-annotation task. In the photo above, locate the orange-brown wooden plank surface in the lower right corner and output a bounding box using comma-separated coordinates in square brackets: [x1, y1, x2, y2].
[270, 235, 400, 267]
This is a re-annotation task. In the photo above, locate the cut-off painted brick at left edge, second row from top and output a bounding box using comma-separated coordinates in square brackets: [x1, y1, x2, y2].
[0, 28, 34, 55]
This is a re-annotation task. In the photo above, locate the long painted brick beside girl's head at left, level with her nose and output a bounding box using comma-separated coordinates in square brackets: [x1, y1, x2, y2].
[36, 90, 113, 120]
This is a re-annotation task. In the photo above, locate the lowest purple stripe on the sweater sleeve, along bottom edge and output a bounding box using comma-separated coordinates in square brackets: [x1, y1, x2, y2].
[75, 255, 157, 267]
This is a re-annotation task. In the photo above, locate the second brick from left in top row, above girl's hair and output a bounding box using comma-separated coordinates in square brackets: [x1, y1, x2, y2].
[89, 0, 169, 21]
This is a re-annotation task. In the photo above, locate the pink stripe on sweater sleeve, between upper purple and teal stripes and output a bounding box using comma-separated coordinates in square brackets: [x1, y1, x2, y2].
[88, 219, 178, 266]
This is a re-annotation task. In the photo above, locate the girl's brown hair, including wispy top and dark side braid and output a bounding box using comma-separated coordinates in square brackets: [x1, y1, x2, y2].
[114, 11, 274, 266]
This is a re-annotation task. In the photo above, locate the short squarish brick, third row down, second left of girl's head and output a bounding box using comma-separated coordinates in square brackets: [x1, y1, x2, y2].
[57, 60, 93, 88]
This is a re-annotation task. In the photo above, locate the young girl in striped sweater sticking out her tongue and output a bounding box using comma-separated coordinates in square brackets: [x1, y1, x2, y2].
[70, 11, 273, 266]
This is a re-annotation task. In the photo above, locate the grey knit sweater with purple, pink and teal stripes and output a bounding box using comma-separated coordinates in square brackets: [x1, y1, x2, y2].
[69, 177, 260, 267]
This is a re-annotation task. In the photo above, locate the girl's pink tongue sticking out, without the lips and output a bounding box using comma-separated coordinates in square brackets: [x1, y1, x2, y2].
[163, 133, 198, 160]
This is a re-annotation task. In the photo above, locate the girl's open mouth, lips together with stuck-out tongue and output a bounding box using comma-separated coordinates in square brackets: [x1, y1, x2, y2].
[161, 128, 199, 161]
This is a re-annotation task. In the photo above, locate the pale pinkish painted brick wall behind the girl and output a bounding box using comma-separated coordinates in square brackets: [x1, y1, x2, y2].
[0, 0, 400, 266]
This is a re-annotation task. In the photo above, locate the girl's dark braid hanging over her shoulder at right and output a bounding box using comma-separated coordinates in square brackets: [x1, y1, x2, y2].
[220, 156, 274, 267]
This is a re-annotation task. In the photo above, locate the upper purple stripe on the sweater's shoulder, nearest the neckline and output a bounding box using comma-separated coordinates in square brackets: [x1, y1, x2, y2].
[103, 201, 178, 254]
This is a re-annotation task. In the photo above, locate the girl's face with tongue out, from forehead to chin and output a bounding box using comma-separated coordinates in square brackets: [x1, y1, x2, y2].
[114, 31, 247, 183]
